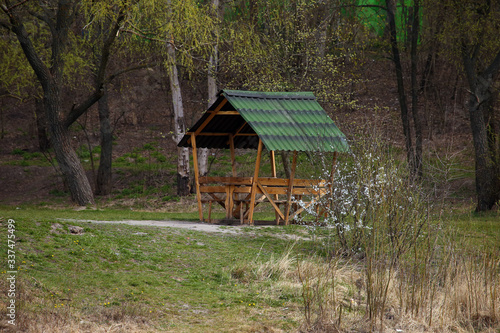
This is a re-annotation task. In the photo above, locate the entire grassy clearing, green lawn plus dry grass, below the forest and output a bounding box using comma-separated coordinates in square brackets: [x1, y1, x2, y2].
[0, 207, 500, 332]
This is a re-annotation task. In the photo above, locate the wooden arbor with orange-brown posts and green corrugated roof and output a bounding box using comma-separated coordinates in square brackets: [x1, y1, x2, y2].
[178, 90, 349, 224]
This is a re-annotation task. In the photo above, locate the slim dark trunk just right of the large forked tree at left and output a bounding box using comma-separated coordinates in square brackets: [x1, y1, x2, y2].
[95, 90, 113, 195]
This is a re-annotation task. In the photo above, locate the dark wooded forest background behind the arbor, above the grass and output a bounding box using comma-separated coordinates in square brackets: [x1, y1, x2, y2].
[0, 0, 500, 211]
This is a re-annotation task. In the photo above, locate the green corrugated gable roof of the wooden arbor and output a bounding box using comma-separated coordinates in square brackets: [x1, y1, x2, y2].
[179, 90, 349, 152]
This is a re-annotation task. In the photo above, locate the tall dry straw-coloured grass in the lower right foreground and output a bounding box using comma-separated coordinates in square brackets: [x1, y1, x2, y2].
[236, 239, 500, 333]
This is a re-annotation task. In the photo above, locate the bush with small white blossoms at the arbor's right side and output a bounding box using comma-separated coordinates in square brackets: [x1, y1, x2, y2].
[299, 140, 428, 254]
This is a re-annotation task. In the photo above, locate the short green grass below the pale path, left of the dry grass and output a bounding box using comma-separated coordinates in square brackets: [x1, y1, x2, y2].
[0, 217, 307, 332]
